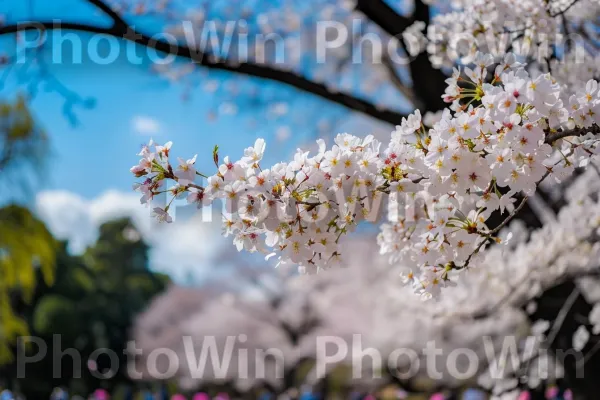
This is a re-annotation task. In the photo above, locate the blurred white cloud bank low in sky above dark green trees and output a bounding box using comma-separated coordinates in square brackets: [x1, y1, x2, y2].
[36, 191, 227, 281]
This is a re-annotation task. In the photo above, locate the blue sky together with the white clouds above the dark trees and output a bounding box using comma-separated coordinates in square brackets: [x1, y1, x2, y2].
[0, 0, 392, 281]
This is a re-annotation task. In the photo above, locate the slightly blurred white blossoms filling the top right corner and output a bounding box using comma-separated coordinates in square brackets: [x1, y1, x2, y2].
[405, 0, 600, 89]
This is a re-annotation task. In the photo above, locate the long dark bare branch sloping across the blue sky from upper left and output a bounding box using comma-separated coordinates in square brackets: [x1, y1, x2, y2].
[0, 10, 406, 125]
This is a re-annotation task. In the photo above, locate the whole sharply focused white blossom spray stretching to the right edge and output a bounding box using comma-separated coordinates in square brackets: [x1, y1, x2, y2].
[132, 54, 600, 298]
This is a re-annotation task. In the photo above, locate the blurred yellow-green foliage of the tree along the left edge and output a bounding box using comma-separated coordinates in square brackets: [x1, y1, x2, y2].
[0, 97, 56, 365]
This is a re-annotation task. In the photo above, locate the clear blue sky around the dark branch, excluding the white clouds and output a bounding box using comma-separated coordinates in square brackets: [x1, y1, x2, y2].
[0, 0, 360, 198]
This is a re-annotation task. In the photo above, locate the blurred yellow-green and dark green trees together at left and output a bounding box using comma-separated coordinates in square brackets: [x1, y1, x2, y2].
[0, 97, 169, 398]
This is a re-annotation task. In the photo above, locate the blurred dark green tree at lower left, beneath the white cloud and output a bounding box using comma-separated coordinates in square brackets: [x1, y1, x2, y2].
[5, 219, 169, 398]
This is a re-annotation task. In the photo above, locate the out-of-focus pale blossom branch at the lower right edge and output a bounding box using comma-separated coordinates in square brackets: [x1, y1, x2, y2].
[464, 161, 600, 399]
